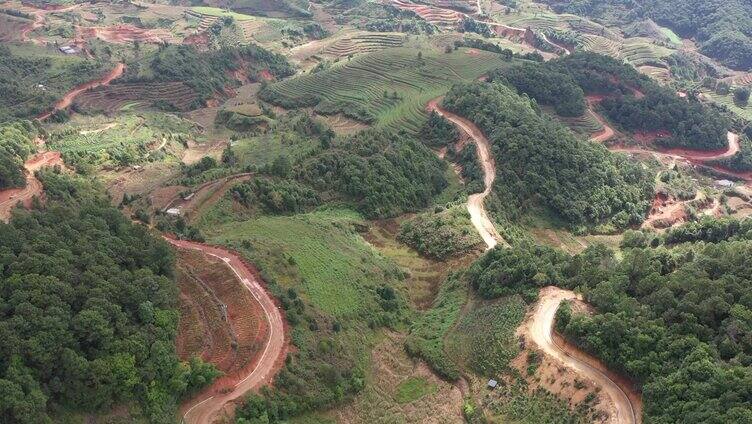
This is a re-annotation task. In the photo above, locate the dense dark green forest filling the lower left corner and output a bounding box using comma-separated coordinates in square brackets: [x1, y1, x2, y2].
[0, 169, 217, 424]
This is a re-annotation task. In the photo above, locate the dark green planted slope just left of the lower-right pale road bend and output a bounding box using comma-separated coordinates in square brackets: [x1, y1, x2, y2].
[446, 296, 526, 375]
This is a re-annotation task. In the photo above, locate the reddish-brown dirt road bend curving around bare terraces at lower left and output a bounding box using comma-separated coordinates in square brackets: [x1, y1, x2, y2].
[165, 237, 285, 424]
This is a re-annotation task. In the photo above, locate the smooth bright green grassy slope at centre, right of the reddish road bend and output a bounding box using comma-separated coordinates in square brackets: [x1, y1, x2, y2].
[203, 210, 406, 319]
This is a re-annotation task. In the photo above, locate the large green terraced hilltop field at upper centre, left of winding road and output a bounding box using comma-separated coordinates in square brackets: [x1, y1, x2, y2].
[262, 48, 505, 132]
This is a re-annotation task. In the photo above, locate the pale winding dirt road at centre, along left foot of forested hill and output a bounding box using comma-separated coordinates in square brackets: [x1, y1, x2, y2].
[427, 98, 507, 249]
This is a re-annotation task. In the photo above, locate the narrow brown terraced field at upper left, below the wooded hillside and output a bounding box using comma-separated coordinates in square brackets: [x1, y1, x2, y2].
[73, 81, 198, 113]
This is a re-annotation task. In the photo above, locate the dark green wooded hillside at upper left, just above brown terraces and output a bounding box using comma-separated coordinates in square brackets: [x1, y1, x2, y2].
[123, 44, 295, 107]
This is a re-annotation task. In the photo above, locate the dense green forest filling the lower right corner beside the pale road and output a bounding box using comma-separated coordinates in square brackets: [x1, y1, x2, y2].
[467, 234, 752, 424]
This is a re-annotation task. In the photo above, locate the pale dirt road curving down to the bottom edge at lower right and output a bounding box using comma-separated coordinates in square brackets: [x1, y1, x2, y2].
[528, 287, 639, 424]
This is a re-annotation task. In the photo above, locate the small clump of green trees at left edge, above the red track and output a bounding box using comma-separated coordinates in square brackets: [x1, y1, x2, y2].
[0, 121, 37, 189]
